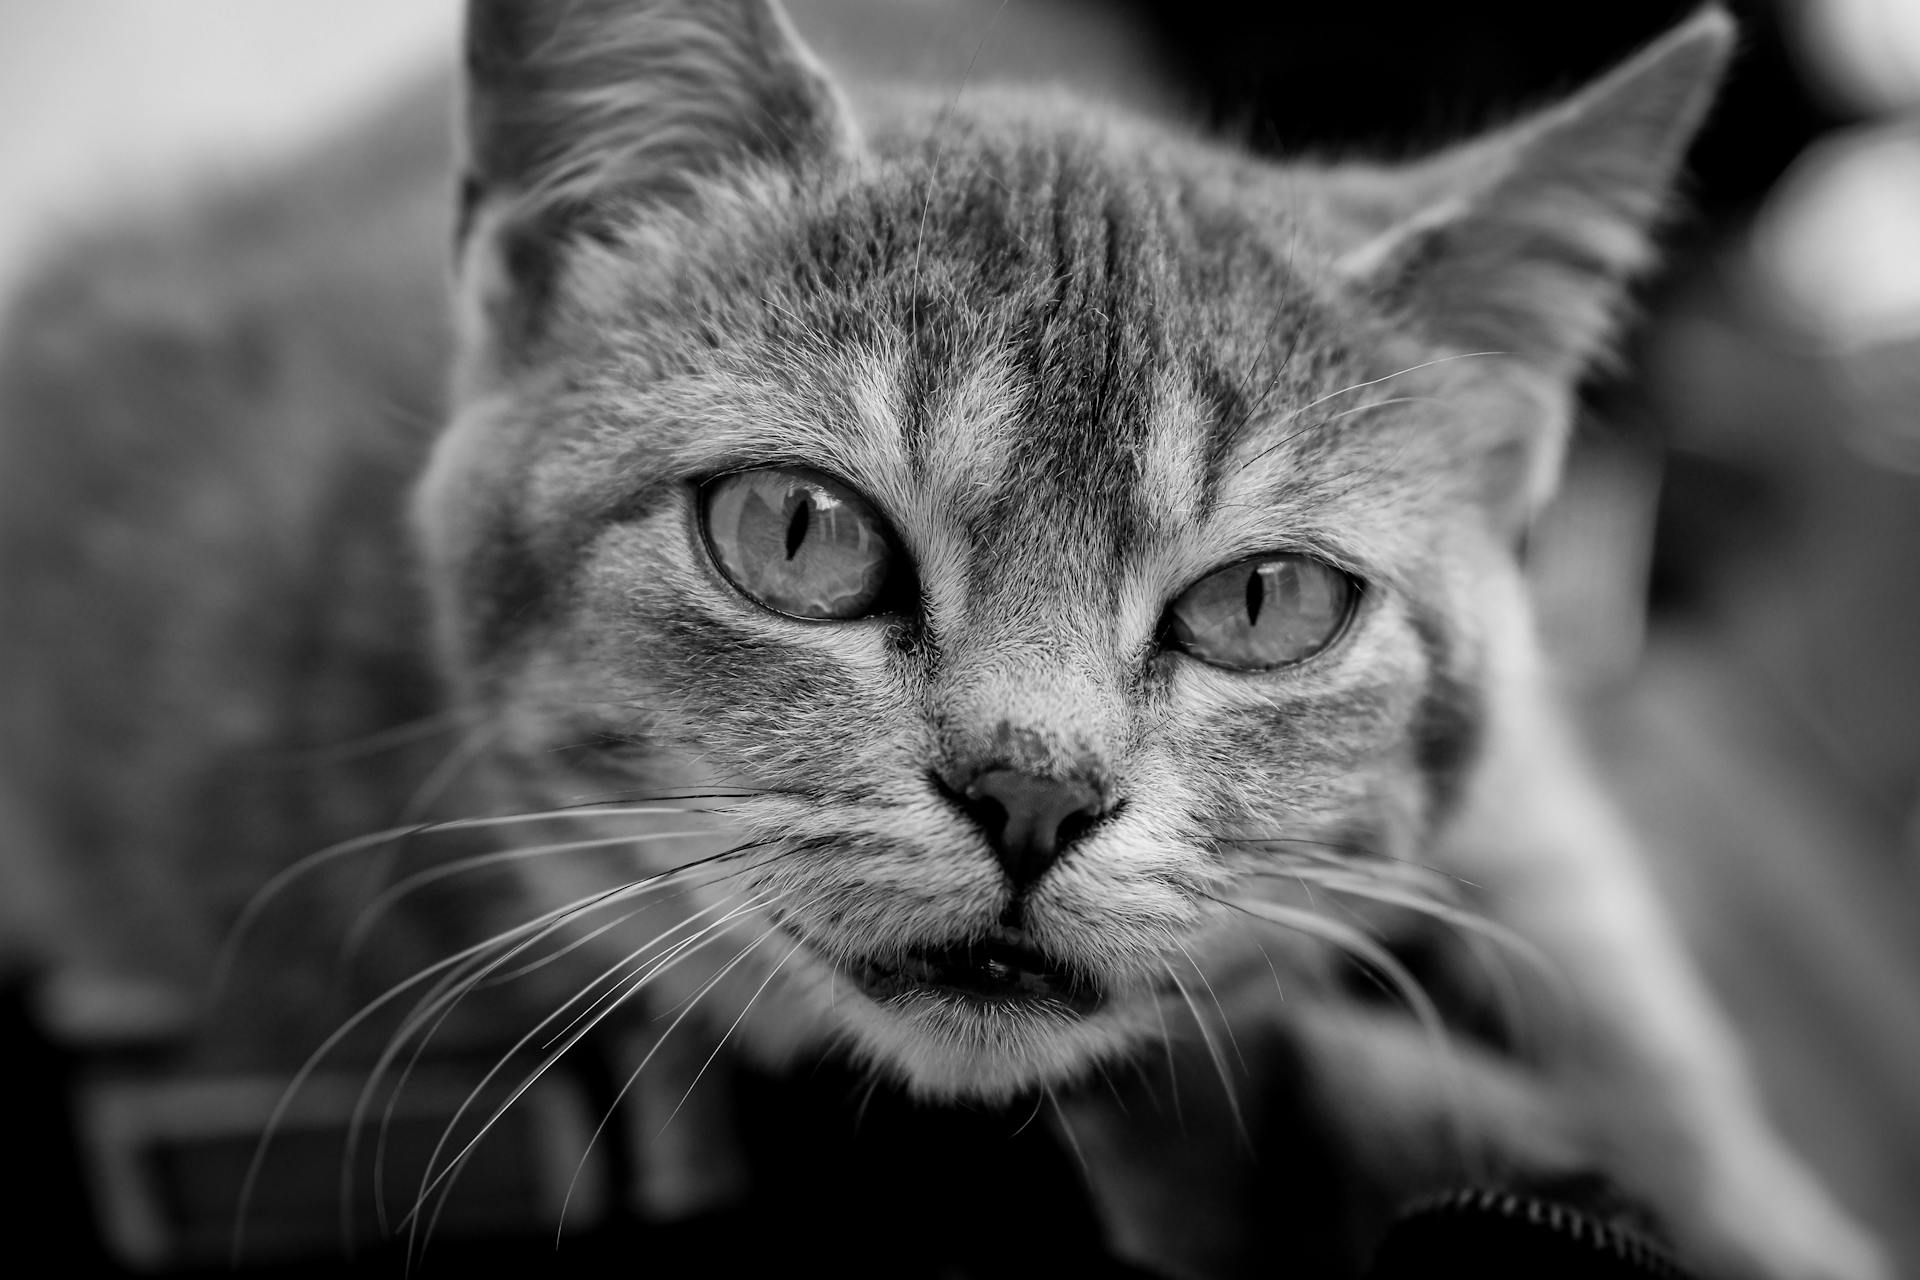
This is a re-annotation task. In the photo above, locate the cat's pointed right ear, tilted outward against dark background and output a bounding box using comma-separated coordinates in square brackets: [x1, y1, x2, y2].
[1329, 8, 1734, 380]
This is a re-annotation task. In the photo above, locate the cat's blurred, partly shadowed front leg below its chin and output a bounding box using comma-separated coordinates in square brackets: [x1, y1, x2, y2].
[1058, 982, 1592, 1278]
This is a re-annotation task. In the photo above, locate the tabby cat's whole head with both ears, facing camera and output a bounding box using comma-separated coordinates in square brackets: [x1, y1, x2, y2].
[419, 0, 1730, 1096]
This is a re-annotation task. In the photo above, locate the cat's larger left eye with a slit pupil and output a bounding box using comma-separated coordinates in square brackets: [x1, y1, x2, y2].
[701, 468, 895, 620]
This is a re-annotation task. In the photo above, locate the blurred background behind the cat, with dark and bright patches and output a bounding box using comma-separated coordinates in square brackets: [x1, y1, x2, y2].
[0, 0, 1920, 1274]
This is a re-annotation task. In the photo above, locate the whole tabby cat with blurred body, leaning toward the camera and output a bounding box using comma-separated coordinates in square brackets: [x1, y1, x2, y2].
[0, 0, 1887, 1280]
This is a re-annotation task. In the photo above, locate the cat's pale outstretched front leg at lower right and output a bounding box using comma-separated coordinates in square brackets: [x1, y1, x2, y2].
[1448, 667, 1889, 1280]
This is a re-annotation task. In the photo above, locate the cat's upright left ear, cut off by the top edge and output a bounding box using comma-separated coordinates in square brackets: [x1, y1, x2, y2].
[457, 0, 856, 355]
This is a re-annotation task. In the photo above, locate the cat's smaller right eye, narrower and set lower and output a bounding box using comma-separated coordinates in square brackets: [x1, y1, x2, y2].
[1167, 555, 1359, 672]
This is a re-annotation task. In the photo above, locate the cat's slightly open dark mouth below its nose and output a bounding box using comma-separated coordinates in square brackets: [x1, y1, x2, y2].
[847, 933, 1102, 1017]
